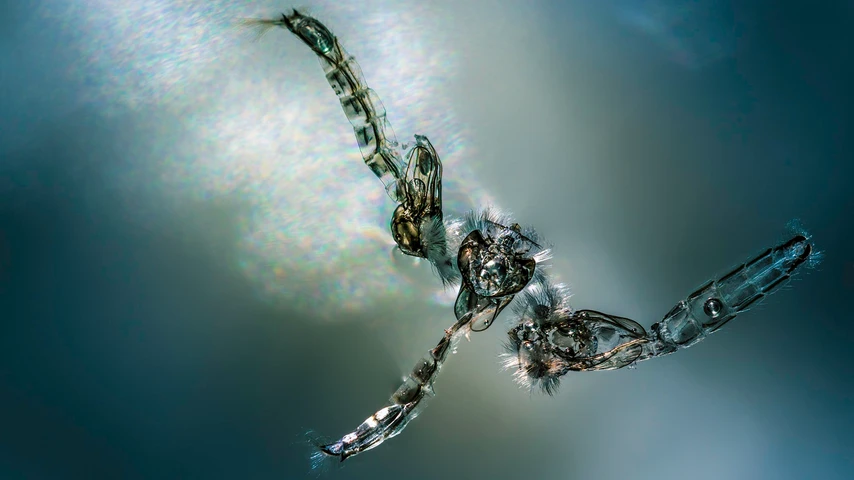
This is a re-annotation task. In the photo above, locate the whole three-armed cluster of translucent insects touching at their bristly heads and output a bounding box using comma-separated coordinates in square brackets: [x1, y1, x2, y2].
[239, 6, 817, 462]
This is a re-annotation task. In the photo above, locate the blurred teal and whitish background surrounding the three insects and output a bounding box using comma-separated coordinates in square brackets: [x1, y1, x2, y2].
[0, 0, 854, 480]
